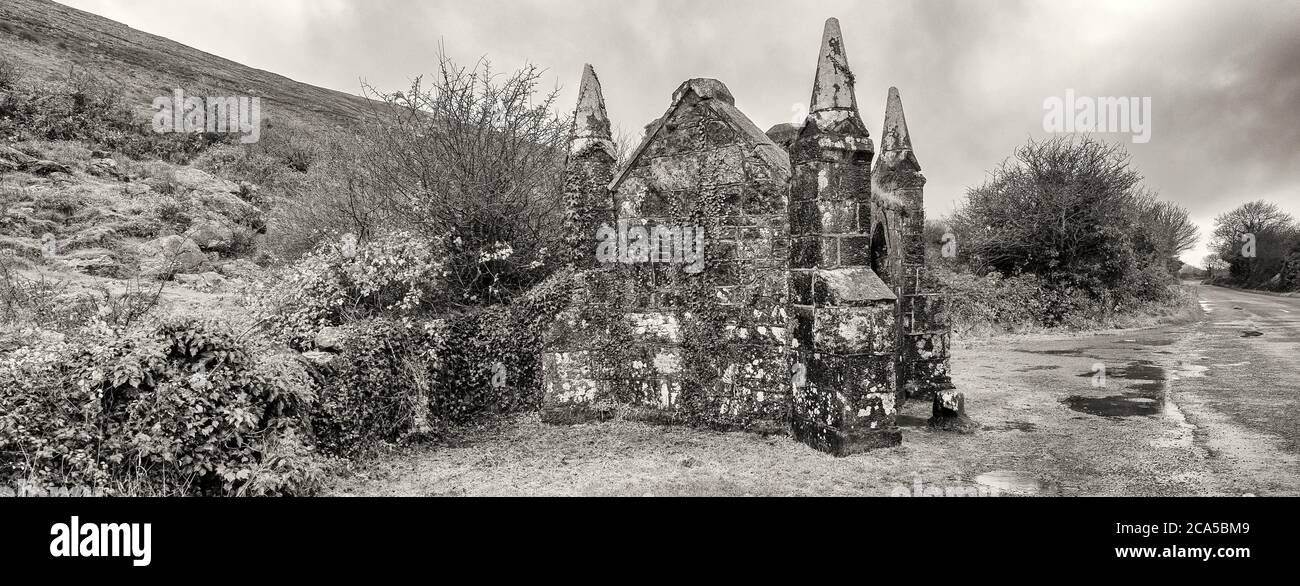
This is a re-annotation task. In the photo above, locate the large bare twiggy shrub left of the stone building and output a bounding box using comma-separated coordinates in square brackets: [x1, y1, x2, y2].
[277, 48, 568, 305]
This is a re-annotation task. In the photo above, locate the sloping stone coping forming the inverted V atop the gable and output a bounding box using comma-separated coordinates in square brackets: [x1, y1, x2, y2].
[610, 78, 790, 191]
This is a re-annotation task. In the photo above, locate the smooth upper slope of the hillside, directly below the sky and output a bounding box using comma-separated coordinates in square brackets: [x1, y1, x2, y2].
[0, 0, 367, 127]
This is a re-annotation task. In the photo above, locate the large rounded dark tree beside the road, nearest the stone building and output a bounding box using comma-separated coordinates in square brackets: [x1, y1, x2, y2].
[950, 136, 1170, 296]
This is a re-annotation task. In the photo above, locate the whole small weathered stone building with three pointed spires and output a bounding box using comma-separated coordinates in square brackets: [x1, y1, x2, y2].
[542, 18, 966, 455]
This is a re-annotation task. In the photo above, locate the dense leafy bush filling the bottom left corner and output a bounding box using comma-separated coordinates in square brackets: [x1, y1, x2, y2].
[0, 320, 321, 495]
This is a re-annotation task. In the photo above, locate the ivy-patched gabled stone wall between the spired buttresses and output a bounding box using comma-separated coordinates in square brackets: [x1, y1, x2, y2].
[543, 79, 789, 430]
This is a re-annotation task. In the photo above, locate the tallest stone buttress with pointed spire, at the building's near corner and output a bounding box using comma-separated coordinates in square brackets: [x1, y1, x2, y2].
[789, 18, 902, 455]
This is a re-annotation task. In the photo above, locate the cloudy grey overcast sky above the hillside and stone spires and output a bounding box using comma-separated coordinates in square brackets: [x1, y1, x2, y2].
[53, 0, 1300, 264]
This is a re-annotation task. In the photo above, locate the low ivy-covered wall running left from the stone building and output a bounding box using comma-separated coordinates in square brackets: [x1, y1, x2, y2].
[312, 268, 571, 455]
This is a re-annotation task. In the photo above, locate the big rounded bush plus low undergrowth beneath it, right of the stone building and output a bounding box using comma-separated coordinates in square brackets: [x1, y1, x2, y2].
[946, 138, 1196, 326]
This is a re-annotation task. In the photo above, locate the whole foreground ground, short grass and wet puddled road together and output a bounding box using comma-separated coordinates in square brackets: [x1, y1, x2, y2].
[329, 287, 1300, 496]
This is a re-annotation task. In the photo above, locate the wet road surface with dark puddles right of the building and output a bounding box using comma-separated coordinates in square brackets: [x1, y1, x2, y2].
[902, 285, 1300, 496]
